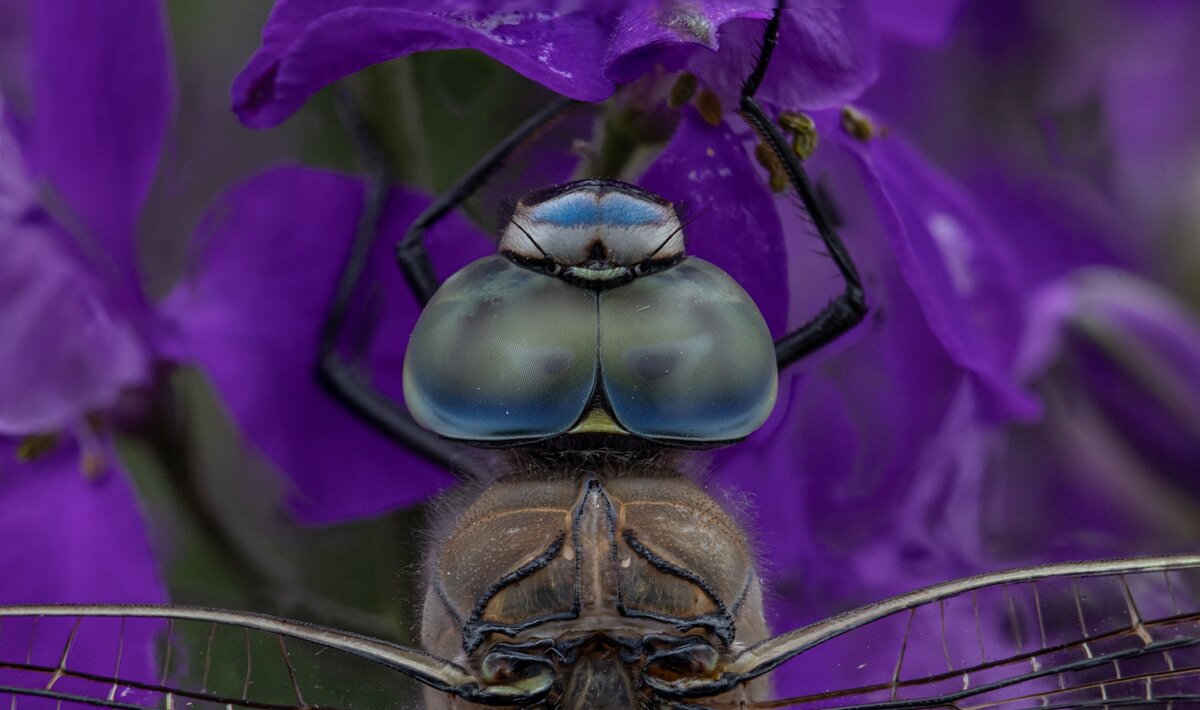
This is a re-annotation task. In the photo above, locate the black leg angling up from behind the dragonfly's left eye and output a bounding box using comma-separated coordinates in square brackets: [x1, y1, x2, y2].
[396, 97, 578, 307]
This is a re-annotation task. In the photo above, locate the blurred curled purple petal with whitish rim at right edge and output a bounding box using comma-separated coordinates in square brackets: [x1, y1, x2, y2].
[989, 274, 1200, 561]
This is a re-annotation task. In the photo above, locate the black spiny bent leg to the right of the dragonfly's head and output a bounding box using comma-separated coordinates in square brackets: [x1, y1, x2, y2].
[738, 0, 866, 369]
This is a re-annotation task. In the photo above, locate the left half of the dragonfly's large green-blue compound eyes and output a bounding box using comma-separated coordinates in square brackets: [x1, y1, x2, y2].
[404, 255, 596, 441]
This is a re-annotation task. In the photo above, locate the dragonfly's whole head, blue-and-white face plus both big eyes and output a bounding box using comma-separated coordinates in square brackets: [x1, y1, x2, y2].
[404, 180, 778, 445]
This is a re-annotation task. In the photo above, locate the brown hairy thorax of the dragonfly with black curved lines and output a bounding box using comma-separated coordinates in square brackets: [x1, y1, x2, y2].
[421, 461, 767, 708]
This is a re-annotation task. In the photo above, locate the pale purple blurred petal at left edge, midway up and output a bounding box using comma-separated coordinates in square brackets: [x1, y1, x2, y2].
[0, 213, 148, 435]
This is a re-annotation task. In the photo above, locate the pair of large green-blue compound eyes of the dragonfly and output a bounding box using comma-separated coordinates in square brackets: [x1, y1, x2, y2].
[404, 255, 778, 444]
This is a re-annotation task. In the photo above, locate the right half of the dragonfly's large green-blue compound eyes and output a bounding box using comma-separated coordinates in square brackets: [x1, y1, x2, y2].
[600, 258, 778, 443]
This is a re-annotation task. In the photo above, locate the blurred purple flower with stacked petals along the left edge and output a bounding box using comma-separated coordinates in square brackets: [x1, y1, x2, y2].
[0, 0, 173, 603]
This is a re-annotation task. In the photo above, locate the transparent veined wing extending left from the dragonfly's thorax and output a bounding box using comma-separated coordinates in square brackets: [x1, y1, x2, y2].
[0, 606, 466, 710]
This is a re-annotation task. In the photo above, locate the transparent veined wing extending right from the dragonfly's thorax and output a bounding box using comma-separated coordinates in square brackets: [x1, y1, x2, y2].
[733, 556, 1200, 710]
